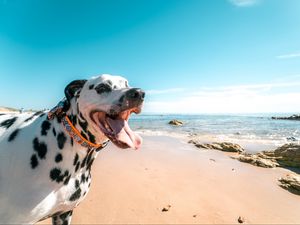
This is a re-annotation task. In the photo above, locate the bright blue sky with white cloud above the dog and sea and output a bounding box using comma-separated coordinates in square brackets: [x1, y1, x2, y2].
[0, 0, 300, 113]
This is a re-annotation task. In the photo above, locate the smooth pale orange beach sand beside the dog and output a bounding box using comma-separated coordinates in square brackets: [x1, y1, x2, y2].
[42, 134, 300, 224]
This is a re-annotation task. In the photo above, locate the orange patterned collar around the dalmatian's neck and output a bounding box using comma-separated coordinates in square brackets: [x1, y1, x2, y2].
[48, 99, 109, 151]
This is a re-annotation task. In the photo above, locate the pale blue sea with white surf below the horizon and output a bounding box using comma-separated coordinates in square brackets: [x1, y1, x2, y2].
[129, 114, 300, 143]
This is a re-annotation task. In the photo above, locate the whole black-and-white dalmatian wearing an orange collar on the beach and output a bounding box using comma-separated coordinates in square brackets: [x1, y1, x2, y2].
[0, 75, 145, 225]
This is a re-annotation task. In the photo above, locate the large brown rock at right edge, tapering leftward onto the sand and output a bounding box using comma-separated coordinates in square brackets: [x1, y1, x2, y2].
[232, 143, 300, 168]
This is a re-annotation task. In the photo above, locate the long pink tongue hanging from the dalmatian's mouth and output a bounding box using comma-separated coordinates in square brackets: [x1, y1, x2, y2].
[107, 118, 142, 149]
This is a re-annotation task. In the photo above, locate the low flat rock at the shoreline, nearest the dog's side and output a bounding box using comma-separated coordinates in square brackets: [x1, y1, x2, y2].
[189, 140, 244, 153]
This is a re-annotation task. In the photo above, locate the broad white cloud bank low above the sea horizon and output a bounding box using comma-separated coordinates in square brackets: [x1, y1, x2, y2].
[144, 82, 300, 113]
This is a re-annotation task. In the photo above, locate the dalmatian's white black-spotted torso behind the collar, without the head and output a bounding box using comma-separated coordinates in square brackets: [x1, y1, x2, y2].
[0, 113, 93, 223]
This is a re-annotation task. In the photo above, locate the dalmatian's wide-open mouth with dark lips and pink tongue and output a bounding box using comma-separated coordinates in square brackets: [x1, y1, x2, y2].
[91, 107, 142, 149]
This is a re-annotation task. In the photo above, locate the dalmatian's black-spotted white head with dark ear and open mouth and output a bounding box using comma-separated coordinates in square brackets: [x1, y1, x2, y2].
[65, 75, 145, 149]
